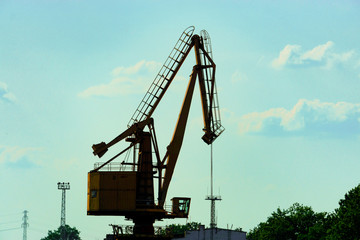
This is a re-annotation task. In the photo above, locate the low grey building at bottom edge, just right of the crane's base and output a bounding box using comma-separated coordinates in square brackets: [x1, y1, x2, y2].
[176, 225, 246, 240]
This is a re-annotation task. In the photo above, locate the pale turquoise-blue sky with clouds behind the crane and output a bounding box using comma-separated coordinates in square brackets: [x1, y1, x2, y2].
[0, 0, 360, 240]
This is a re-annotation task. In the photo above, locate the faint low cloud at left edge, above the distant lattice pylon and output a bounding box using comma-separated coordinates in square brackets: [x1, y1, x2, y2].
[0, 145, 41, 168]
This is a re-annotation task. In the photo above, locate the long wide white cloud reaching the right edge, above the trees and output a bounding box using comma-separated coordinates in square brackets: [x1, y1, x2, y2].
[239, 99, 360, 136]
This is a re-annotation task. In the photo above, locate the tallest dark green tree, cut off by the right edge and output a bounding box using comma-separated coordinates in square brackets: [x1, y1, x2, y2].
[327, 184, 360, 240]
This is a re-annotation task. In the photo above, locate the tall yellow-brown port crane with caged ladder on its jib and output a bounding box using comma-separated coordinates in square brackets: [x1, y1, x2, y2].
[87, 26, 224, 239]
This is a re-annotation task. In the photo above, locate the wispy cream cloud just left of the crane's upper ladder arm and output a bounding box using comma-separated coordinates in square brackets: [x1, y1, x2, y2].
[78, 60, 161, 98]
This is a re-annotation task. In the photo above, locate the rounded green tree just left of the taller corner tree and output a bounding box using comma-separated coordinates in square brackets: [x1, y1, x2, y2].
[247, 203, 327, 240]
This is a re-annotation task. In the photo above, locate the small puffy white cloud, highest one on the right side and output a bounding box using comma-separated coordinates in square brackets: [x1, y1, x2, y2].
[272, 41, 354, 69]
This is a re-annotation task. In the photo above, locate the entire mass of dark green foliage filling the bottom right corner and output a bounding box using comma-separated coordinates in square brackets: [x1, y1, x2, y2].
[247, 184, 360, 240]
